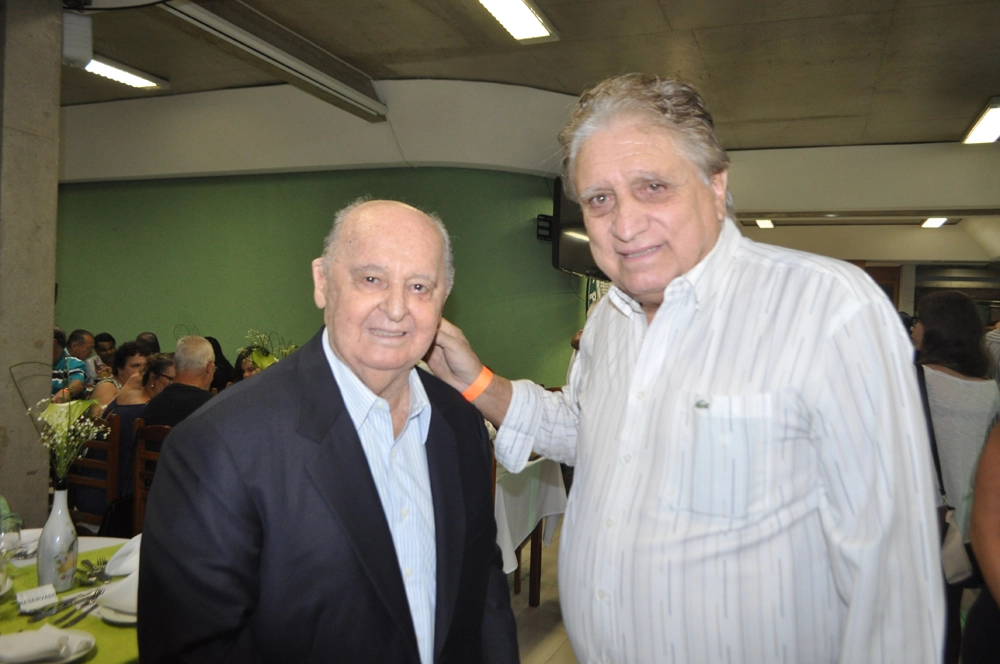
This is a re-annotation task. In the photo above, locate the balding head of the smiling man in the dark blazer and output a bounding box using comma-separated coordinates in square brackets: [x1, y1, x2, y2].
[313, 201, 452, 399]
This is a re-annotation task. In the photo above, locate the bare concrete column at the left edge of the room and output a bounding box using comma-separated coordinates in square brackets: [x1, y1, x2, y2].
[0, 0, 62, 527]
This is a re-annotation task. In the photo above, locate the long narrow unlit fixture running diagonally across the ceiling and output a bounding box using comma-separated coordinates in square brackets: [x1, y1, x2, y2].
[159, 0, 389, 121]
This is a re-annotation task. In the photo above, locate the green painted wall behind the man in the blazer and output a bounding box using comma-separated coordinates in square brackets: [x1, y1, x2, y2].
[56, 168, 584, 385]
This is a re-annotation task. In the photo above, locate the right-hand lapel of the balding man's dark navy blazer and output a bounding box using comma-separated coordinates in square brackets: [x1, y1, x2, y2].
[426, 394, 465, 661]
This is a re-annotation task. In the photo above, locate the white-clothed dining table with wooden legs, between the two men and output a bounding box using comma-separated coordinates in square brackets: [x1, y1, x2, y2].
[494, 457, 566, 606]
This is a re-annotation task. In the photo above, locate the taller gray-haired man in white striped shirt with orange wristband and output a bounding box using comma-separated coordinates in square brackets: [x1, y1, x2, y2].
[430, 74, 944, 664]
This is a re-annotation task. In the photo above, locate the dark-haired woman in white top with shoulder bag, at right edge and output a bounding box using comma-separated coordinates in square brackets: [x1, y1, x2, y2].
[912, 291, 1000, 661]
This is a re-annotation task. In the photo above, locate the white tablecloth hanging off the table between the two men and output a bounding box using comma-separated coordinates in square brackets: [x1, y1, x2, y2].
[494, 458, 566, 574]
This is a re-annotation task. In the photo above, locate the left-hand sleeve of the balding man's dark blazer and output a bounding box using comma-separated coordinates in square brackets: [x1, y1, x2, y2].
[138, 417, 261, 664]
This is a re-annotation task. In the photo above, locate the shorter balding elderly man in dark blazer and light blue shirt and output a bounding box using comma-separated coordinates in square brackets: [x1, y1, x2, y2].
[138, 201, 517, 664]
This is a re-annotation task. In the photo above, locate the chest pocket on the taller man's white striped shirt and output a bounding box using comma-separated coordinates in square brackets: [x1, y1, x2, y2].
[665, 392, 780, 519]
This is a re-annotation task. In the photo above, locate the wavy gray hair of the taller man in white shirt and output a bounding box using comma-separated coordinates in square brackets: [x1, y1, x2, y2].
[559, 74, 733, 217]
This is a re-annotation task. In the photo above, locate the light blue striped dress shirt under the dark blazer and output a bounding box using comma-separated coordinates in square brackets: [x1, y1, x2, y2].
[323, 329, 437, 664]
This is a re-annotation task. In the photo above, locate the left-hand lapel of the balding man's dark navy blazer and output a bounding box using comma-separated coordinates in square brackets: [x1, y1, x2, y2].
[297, 332, 422, 661]
